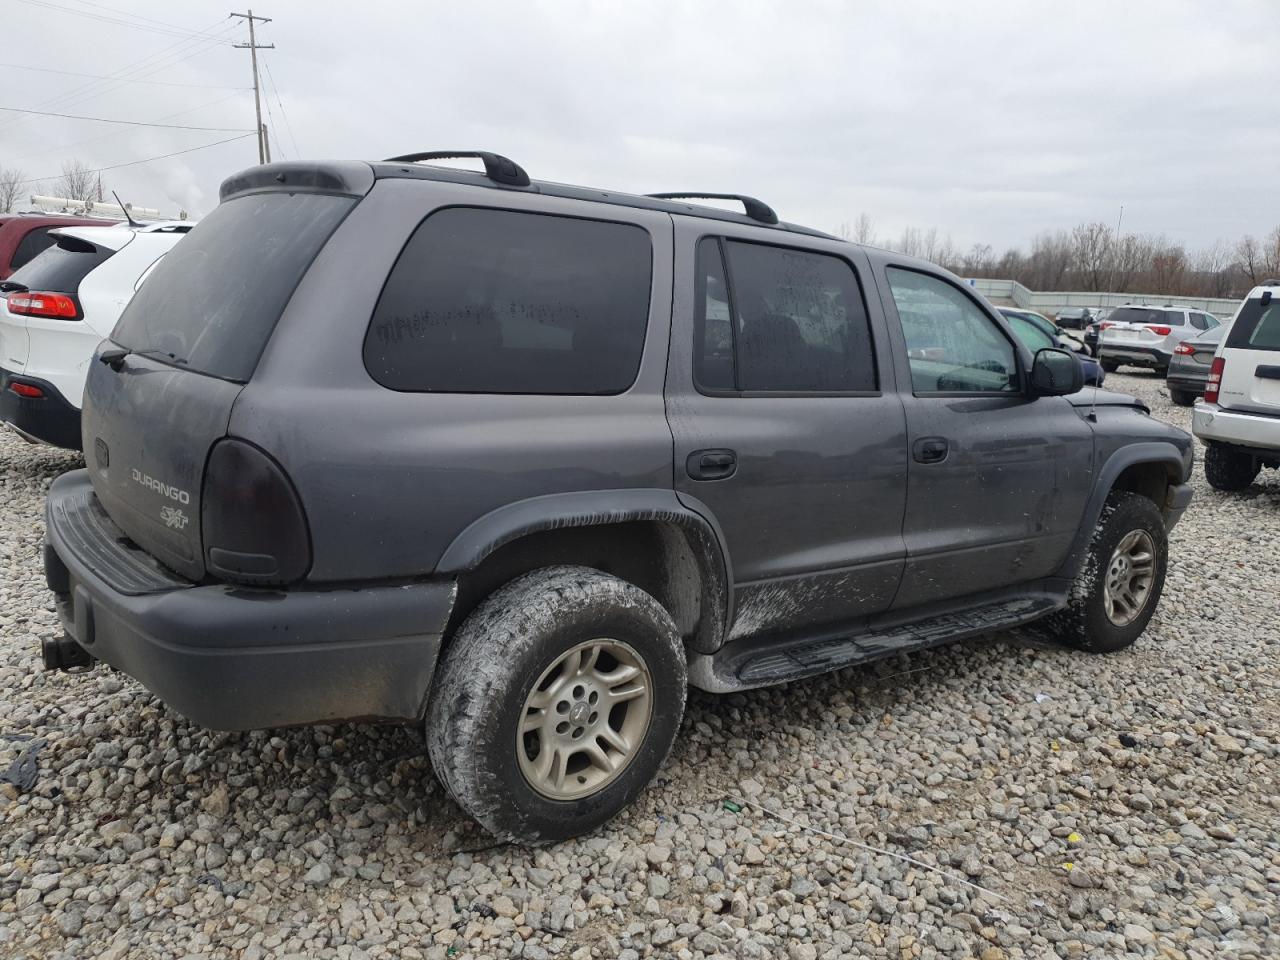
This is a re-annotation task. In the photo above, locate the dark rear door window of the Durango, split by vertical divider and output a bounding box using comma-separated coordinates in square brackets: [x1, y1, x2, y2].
[694, 239, 876, 393]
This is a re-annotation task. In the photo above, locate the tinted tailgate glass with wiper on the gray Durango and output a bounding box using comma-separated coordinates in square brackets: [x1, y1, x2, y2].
[111, 193, 356, 381]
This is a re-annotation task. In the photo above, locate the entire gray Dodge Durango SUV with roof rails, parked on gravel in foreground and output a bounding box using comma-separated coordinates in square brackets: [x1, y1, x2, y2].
[44, 154, 1192, 842]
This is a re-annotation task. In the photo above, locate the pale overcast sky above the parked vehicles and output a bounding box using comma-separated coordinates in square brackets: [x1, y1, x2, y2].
[0, 0, 1280, 250]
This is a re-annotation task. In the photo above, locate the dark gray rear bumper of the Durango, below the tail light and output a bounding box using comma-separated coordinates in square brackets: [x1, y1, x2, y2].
[45, 470, 454, 730]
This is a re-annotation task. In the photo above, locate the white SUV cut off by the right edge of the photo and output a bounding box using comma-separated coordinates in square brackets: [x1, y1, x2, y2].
[1192, 280, 1280, 490]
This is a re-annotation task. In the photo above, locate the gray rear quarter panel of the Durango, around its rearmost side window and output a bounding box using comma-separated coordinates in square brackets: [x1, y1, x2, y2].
[229, 179, 672, 582]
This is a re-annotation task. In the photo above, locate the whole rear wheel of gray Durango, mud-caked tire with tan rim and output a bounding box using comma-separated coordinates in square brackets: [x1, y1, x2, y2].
[426, 566, 687, 845]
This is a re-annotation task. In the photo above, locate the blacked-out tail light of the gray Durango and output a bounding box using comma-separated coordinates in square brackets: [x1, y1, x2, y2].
[200, 438, 311, 585]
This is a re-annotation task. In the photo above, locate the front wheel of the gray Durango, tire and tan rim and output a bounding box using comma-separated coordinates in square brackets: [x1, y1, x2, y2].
[1034, 492, 1169, 653]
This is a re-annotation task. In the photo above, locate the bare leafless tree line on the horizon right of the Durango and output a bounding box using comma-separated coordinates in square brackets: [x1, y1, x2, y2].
[840, 214, 1280, 298]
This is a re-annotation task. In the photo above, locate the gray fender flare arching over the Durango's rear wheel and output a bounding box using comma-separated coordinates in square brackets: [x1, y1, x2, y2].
[435, 489, 733, 652]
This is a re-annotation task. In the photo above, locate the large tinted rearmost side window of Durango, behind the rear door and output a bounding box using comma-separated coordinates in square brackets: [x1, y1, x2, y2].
[365, 207, 653, 394]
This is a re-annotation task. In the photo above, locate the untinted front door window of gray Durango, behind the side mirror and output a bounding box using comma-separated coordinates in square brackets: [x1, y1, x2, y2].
[886, 268, 1021, 393]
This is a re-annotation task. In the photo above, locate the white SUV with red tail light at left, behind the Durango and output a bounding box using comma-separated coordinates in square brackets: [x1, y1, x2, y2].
[0, 221, 193, 449]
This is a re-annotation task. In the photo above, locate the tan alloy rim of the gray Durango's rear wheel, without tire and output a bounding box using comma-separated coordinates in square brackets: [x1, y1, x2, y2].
[516, 639, 653, 800]
